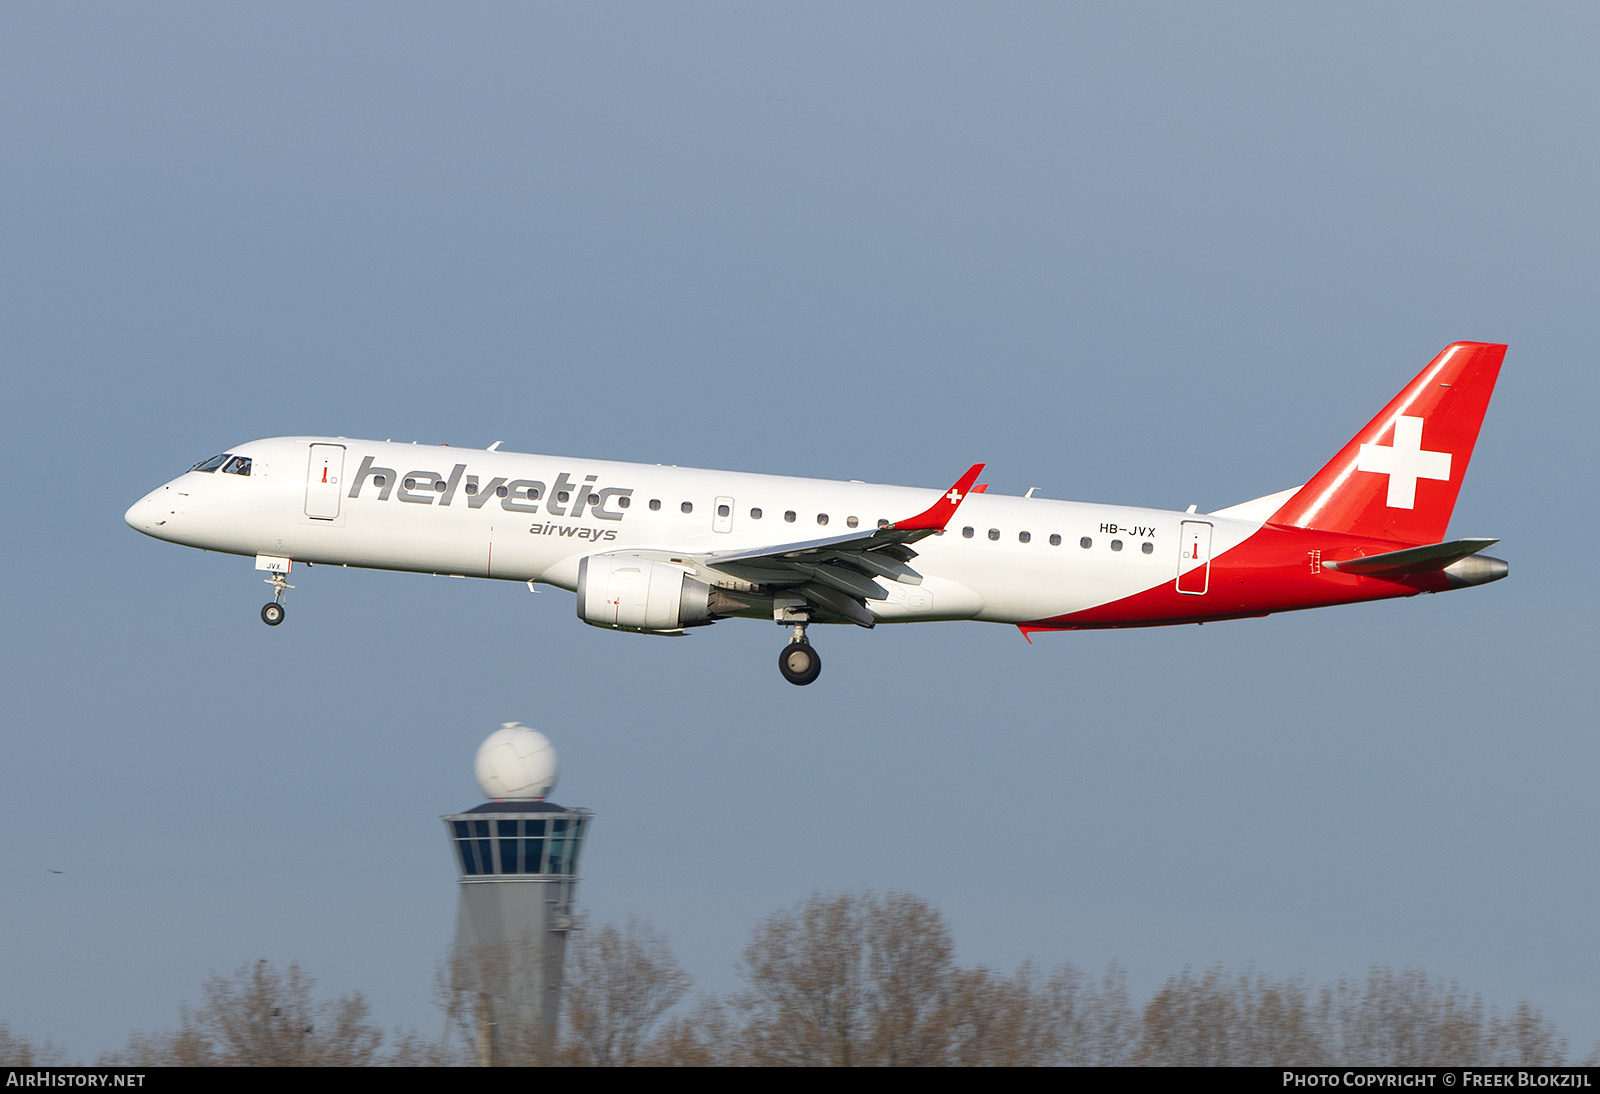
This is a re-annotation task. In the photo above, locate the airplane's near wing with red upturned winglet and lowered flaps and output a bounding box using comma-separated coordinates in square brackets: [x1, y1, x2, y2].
[598, 464, 984, 627]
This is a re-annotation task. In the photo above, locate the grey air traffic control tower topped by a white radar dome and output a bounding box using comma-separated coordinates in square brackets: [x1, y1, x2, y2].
[445, 721, 594, 1065]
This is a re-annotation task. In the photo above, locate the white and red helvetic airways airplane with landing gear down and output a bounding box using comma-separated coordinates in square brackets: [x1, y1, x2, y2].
[126, 342, 1509, 685]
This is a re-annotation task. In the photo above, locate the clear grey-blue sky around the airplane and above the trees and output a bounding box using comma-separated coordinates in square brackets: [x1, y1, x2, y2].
[0, 3, 1600, 1057]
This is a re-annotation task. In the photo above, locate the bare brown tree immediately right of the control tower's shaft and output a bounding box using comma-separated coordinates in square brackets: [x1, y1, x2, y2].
[563, 920, 693, 1067]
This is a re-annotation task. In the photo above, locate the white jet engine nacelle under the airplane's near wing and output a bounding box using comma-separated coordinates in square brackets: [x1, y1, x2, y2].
[578, 555, 717, 633]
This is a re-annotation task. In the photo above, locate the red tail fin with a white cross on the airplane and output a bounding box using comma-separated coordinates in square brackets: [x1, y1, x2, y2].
[1270, 342, 1506, 544]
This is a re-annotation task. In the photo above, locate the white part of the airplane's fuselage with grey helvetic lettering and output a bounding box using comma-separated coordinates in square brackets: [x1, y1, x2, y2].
[126, 437, 1261, 624]
